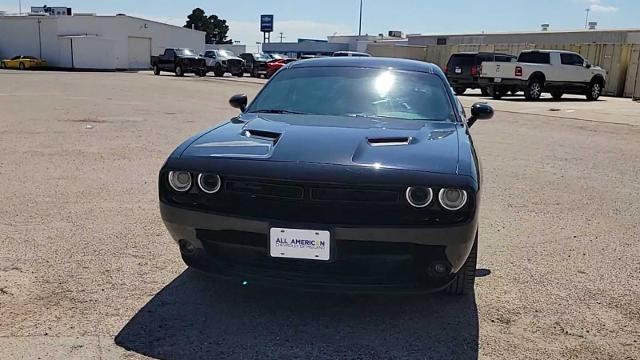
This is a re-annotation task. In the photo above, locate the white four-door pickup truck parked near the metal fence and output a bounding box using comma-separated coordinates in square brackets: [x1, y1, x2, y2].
[478, 50, 607, 100]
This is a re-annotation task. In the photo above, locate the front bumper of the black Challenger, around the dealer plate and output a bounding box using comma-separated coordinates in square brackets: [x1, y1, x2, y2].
[160, 202, 478, 292]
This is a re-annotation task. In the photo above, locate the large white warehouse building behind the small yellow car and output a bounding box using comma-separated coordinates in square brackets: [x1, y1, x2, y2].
[0, 14, 205, 70]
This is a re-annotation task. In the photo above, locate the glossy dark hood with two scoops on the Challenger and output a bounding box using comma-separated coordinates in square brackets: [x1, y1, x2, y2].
[181, 114, 460, 174]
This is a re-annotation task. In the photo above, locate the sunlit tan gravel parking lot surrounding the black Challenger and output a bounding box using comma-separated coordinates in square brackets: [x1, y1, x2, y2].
[0, 71, 640, 359]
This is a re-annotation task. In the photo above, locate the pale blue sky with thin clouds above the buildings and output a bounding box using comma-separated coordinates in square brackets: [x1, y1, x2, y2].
[0, 0, 640, 45]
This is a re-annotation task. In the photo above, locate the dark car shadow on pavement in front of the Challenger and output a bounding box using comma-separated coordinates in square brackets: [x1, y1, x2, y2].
[115, 270, 478, 359]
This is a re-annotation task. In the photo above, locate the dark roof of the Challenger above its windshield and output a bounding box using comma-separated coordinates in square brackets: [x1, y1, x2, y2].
[289, 56, 440, 73]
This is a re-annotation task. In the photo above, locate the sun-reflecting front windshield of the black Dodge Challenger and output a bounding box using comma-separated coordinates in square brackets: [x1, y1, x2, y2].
[247, 67, 454, 121]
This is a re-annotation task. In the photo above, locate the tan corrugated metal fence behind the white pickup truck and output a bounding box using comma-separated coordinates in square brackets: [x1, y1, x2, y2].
[367, 43, 640, 97]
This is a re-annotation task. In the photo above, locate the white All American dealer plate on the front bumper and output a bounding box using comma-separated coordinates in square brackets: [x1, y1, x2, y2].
[269, 228, 331, 261]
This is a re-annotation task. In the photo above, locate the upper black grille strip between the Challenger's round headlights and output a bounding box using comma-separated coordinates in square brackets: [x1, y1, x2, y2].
[160, 175, 474, 226]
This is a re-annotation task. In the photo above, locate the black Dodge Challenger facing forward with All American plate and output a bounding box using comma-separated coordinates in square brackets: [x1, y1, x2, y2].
[159, 57, 493, 295]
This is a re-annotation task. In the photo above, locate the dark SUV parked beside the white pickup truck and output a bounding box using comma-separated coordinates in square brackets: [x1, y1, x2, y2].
[444, 52, 516, 96]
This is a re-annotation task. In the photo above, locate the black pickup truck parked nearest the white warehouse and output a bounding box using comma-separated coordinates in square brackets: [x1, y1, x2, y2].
[151, 49, 207, 76]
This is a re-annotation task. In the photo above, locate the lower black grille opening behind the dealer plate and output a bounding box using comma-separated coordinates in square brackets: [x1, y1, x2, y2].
[197, 230, 446, 285]
